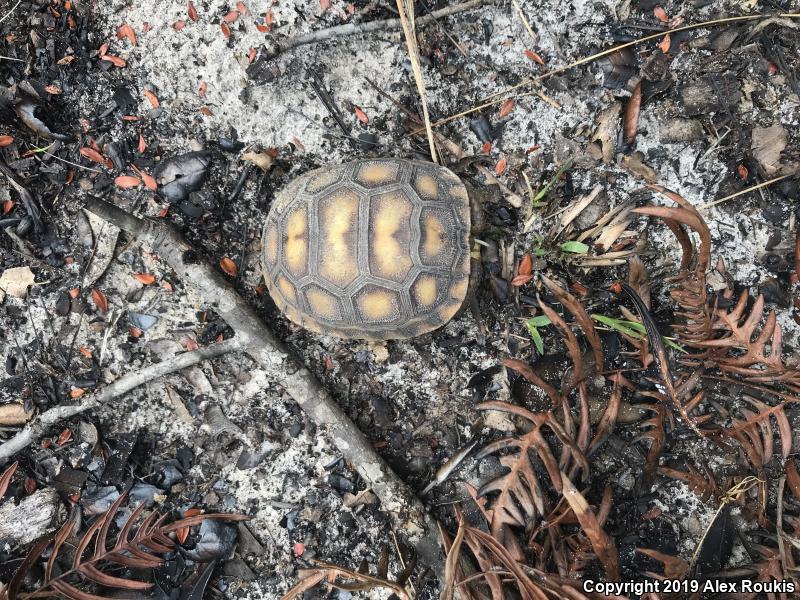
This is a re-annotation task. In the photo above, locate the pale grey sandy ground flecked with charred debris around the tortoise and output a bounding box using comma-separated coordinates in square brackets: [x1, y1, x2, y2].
[0, 0, 800, 599]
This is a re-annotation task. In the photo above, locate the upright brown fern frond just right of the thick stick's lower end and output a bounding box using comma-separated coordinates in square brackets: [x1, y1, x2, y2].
[476, 402, 589, 560]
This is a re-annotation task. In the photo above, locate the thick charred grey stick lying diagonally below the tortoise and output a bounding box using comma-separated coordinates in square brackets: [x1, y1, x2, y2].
[85, 198, 444, 576]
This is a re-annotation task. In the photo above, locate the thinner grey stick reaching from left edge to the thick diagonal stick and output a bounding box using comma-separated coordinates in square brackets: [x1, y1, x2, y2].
[0, 338, 240, 463]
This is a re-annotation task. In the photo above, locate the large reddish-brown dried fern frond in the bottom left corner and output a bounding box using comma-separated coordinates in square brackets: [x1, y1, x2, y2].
[7, 494, 249, 600]
